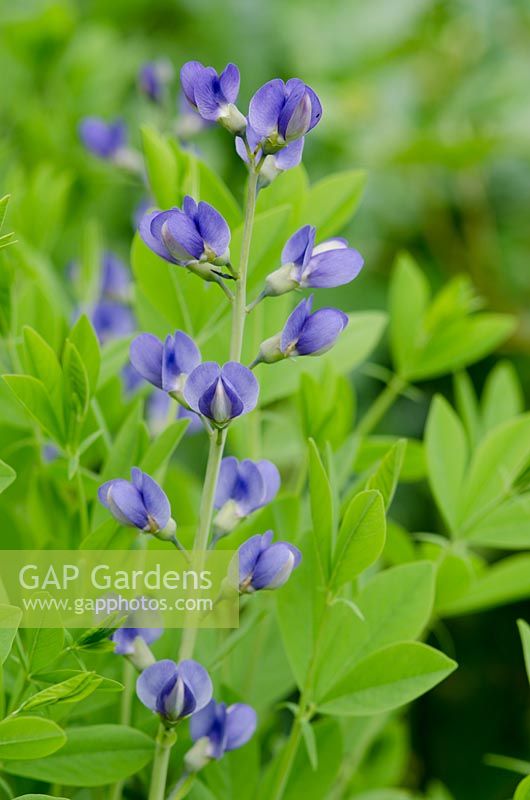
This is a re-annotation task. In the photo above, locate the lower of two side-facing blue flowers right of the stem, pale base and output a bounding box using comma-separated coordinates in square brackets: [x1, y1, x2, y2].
[252, 296, 349, 366]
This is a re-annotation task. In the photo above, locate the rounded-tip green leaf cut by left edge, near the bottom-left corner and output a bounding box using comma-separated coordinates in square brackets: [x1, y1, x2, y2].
[0, 717, 66, 760]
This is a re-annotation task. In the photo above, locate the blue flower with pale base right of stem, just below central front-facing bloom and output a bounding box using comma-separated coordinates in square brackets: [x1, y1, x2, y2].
[214, 456, 280, 533]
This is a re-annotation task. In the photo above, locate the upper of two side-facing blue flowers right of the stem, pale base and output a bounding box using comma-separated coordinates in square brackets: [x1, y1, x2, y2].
[261, 225, 364, 297]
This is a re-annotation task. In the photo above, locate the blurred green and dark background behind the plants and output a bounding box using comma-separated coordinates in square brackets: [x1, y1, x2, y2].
[0, 0, 530, 800]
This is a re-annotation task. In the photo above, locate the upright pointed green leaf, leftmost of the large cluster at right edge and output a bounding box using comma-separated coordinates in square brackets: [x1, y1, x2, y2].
[425, 395, 468, 532]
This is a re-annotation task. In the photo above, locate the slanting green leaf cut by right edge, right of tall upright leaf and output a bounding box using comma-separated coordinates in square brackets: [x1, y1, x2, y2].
[457, 414, 530, 527]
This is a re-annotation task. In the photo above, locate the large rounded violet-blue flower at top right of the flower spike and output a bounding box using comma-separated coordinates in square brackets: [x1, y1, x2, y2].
[248, 78, 322, 155]
